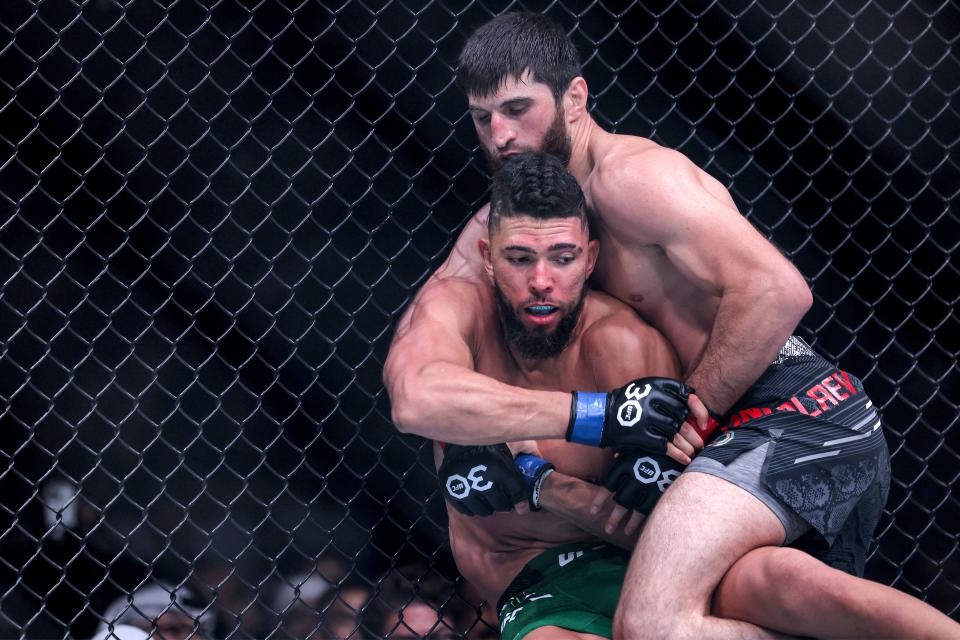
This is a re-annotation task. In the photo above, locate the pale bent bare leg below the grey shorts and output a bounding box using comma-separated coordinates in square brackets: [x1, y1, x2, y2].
[613, 472, 785, 640]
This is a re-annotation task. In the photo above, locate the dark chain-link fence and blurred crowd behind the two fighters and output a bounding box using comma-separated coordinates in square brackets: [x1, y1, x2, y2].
[0, 0, 960, 638]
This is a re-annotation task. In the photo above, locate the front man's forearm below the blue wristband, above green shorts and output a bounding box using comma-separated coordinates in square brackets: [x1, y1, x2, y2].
[540, 471, 640, 550]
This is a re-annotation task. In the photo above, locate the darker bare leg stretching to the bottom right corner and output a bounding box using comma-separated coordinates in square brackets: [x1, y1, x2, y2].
[713, 547, 960, 640]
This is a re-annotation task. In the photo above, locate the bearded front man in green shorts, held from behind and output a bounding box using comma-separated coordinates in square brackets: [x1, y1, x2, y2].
[395, 154, 679, 638]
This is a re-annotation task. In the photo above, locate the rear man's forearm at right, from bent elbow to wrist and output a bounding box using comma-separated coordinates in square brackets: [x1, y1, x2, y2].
[686, 290, 809, 413]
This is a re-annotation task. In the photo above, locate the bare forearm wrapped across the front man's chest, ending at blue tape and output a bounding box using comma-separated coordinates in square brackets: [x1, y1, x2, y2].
[390, 363, 571, 445]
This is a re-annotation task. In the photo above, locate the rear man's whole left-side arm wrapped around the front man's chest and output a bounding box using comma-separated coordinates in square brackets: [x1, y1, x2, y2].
[384, 277, 571, 445]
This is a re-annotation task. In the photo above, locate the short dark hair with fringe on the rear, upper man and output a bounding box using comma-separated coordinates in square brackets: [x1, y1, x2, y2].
[457, 11, 582, 104]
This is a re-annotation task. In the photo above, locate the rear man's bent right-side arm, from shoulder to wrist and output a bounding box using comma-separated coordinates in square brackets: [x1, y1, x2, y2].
[592, 148, 812, 413]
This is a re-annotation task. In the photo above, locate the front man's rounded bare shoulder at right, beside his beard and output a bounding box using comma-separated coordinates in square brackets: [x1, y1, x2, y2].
[580, 291, 680, 388]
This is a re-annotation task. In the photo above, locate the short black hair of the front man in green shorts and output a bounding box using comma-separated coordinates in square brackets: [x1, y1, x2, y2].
[487, 151, 590, 233]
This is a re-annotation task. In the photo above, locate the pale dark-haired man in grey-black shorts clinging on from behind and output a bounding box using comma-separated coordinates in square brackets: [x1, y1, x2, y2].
[385, 14, 958, 638]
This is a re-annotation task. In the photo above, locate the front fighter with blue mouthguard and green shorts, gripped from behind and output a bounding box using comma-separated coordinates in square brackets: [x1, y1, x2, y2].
[386, 154, 956, 639]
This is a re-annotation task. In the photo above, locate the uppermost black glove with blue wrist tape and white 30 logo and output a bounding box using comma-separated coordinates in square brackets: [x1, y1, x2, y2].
[567, 378, 693, 453]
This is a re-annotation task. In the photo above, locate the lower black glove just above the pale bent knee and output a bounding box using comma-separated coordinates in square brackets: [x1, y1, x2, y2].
[603, 450, 683, 515]
